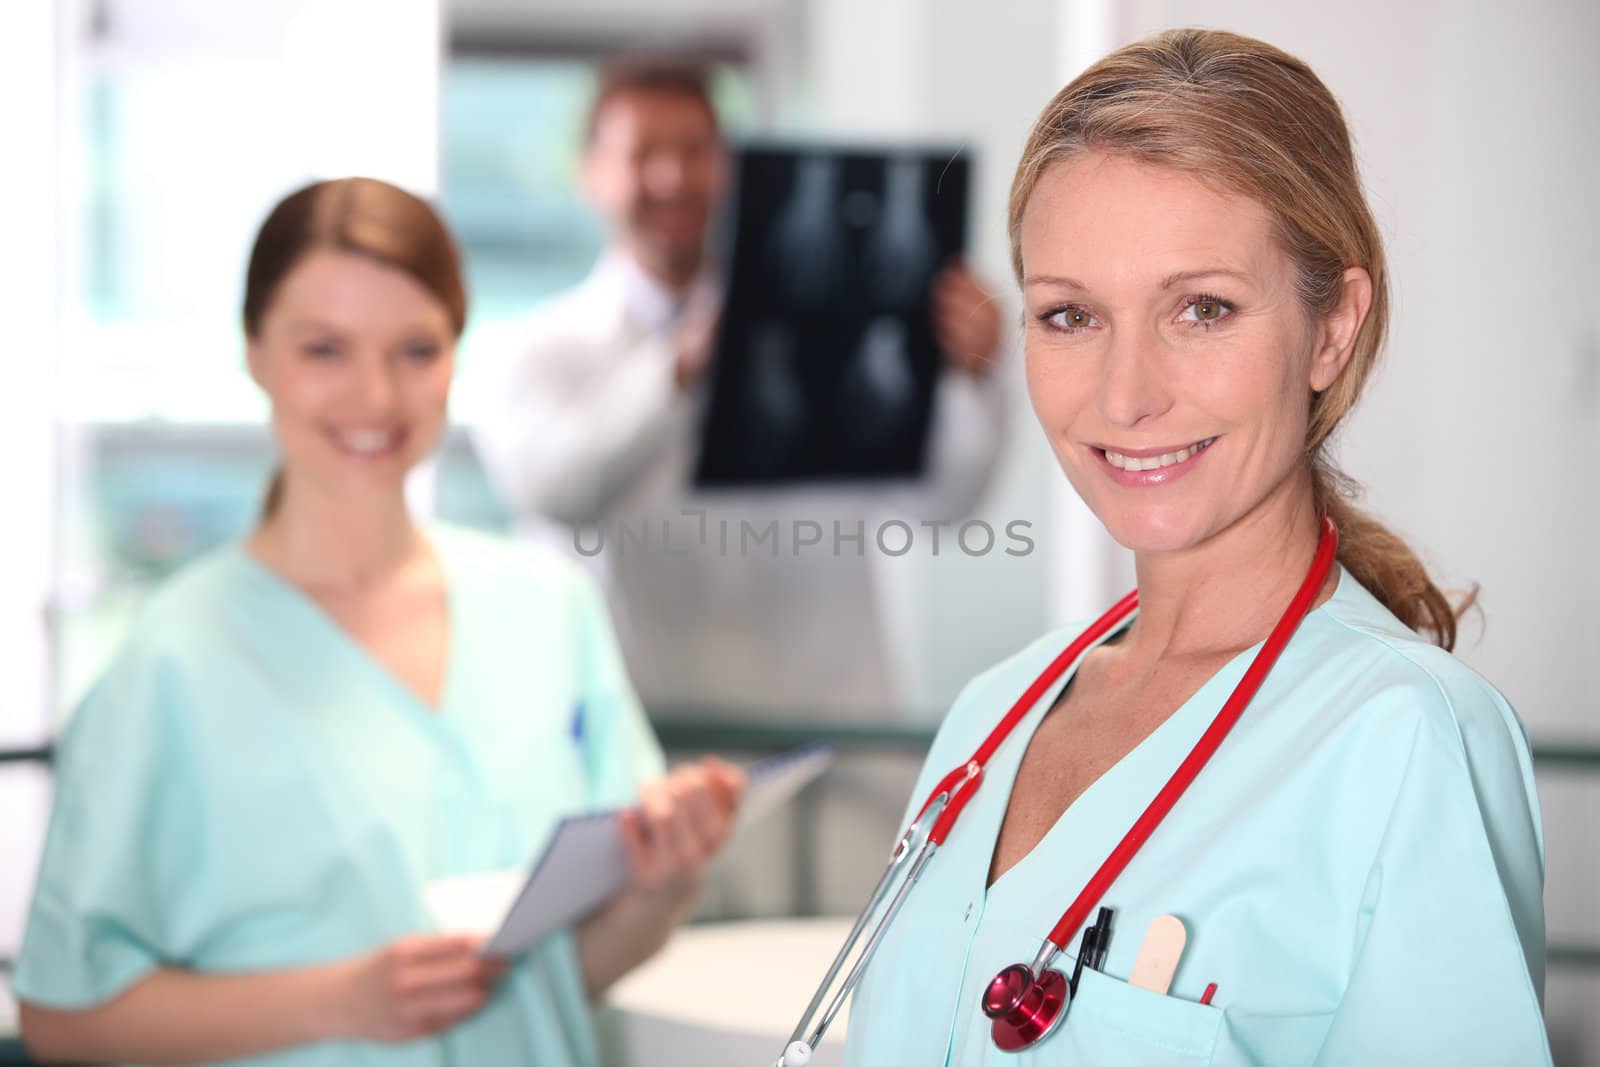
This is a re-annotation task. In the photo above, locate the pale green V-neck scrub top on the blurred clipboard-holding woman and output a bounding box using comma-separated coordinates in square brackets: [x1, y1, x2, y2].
[13, 528, 662, 1067]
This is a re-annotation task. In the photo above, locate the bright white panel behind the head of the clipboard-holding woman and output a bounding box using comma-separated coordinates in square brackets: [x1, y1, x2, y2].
[65, 0, 440, 422]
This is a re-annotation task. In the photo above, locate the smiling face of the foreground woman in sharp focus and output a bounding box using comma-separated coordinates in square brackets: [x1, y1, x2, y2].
[1021, 155, 1365, 552]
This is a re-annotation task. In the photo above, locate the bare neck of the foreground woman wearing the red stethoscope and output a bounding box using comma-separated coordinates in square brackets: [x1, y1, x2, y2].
[1125, 472, 1338, 662]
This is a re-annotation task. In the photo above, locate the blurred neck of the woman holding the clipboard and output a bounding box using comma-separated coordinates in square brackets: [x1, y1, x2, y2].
[246, 478, 427, 595]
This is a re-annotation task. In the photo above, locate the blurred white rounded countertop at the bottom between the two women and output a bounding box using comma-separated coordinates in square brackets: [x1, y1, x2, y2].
[597, 918, 853, 1067]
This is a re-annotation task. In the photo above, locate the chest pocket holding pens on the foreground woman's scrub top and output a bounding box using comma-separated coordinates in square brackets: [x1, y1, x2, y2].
[950, 969, 1222, 1067]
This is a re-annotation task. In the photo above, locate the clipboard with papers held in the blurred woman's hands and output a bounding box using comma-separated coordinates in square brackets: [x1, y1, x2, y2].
[422, 744, 834, 955]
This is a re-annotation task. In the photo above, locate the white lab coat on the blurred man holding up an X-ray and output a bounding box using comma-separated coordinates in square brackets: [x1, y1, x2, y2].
[475, 251, 1003, 718]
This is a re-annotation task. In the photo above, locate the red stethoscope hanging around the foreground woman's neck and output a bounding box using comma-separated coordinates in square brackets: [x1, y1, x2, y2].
[776, 518, 1339, 1067]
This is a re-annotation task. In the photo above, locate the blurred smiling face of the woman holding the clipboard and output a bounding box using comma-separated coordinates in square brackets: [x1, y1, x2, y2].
[248, 251, 456, 511]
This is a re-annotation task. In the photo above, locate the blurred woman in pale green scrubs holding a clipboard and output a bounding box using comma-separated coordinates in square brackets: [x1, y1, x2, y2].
[14, 179, 741, 1067]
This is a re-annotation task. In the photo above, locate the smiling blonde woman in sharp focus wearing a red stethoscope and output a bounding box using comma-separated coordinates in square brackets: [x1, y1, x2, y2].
[846, 30, 1550, 1067]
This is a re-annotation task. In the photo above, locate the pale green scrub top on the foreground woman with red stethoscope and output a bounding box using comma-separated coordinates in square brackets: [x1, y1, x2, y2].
[846, 568, 1550, 1067]
